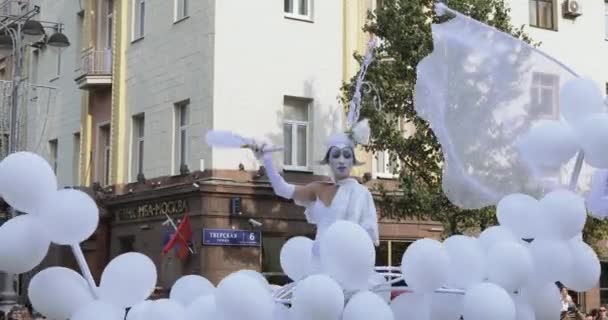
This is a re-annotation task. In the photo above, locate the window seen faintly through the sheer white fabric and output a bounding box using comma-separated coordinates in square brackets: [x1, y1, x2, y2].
[530, 72, 559, 120]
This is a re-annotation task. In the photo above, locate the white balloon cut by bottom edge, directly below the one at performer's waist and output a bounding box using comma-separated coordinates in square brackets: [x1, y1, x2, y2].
[342, 291, 394, 320]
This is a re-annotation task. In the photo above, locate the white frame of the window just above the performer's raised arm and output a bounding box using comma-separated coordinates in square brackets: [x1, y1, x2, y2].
[282, 96, 312, 171]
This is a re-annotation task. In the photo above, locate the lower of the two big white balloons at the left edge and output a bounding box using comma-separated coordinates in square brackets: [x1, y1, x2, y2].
[0, 214, 51, 273]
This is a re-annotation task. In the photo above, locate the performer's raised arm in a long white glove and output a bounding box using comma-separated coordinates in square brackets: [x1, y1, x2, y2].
[261, 153, 317, 203]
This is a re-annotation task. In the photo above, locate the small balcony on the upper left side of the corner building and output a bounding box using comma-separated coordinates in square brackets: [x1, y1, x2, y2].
[74, 48, 112, 90]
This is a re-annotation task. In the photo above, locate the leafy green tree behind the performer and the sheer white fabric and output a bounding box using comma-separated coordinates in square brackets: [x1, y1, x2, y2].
[343, 0, 607, 240]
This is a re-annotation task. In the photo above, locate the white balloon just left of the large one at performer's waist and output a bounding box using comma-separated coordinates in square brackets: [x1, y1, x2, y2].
[280, 237, 313, 281]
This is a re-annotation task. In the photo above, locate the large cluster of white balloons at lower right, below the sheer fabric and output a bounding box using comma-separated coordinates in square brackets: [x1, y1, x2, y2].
[392, 190, 601, 320]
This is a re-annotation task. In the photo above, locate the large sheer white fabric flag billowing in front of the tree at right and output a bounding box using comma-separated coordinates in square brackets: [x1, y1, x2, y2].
[414, 4, 576, 209]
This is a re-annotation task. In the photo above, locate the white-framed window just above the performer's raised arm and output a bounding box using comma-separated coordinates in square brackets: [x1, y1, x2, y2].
[283, 97, 311, 169]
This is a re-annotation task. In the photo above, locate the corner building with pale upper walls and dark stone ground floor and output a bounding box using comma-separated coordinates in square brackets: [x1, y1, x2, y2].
[13, 0, 442, 298]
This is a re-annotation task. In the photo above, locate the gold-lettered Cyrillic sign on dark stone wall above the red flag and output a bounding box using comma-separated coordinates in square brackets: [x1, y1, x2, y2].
[116, 200, 188, 221]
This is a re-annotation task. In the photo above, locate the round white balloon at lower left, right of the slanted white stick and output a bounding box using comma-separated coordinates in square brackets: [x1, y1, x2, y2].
[99, 252, 156, 307]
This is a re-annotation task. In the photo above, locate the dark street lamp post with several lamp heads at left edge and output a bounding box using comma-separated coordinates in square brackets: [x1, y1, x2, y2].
[0, 6, 70, 311]
